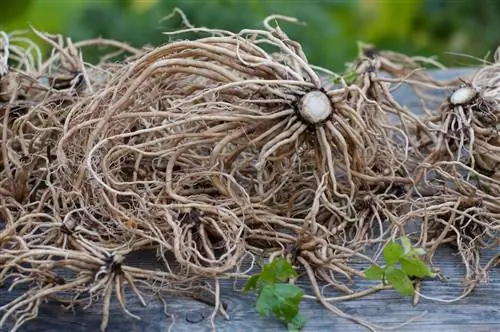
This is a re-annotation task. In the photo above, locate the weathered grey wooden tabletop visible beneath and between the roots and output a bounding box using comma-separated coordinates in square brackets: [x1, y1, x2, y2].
[0, 71, 500, 332]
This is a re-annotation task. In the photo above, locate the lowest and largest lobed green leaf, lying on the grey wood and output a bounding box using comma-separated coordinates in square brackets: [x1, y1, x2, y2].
[256, 284, 304, 323]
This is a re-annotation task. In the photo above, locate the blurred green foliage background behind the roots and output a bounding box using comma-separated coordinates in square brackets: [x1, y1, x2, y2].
[0, 0, 500, 71]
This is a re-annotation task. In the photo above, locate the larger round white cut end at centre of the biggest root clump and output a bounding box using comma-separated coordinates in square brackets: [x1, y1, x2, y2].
[299, 91, 332, 124]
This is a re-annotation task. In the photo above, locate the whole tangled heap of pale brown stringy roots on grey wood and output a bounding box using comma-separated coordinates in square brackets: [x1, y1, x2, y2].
[0, 16, 500, 330]
